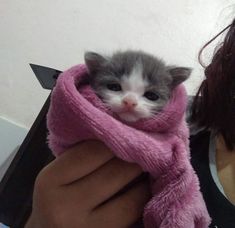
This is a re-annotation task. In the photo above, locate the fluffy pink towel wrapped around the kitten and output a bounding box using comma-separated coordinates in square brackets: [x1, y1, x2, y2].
[47, 65, 210, 228]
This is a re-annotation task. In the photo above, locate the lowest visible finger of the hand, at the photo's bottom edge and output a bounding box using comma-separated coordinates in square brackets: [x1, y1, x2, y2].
[91, 180, 150, 228]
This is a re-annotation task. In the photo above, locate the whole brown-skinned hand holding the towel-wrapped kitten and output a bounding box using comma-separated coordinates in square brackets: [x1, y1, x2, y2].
[25, 141, 150, 228]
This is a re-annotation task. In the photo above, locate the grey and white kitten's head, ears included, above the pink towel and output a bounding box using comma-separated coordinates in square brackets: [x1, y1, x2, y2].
[85, 51, 191, 122]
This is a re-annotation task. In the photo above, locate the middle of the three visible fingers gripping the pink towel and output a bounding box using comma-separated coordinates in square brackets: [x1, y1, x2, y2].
[66, 158, 142, 209]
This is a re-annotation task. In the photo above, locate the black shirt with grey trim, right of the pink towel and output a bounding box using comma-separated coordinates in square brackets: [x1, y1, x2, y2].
[190, 131, 235, 228]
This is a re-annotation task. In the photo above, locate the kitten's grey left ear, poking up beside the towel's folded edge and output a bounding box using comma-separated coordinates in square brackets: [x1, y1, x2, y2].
[84, 52, 108, 73]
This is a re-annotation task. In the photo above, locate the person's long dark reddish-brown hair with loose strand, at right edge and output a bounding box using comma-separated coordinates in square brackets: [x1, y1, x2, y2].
[191, 19, 235, 150]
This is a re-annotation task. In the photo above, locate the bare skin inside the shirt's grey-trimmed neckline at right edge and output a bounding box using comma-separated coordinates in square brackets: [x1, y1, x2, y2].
[216, 135, 235, 205]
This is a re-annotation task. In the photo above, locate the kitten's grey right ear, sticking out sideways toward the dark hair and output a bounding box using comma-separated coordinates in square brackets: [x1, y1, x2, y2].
[168, 67, 192, 88]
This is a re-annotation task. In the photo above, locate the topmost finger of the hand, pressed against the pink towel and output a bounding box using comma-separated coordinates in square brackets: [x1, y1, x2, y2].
[39, 141, 114, 186]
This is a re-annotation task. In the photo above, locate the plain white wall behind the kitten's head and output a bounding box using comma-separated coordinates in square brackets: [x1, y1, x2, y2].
[0, 0, 235, 127]
